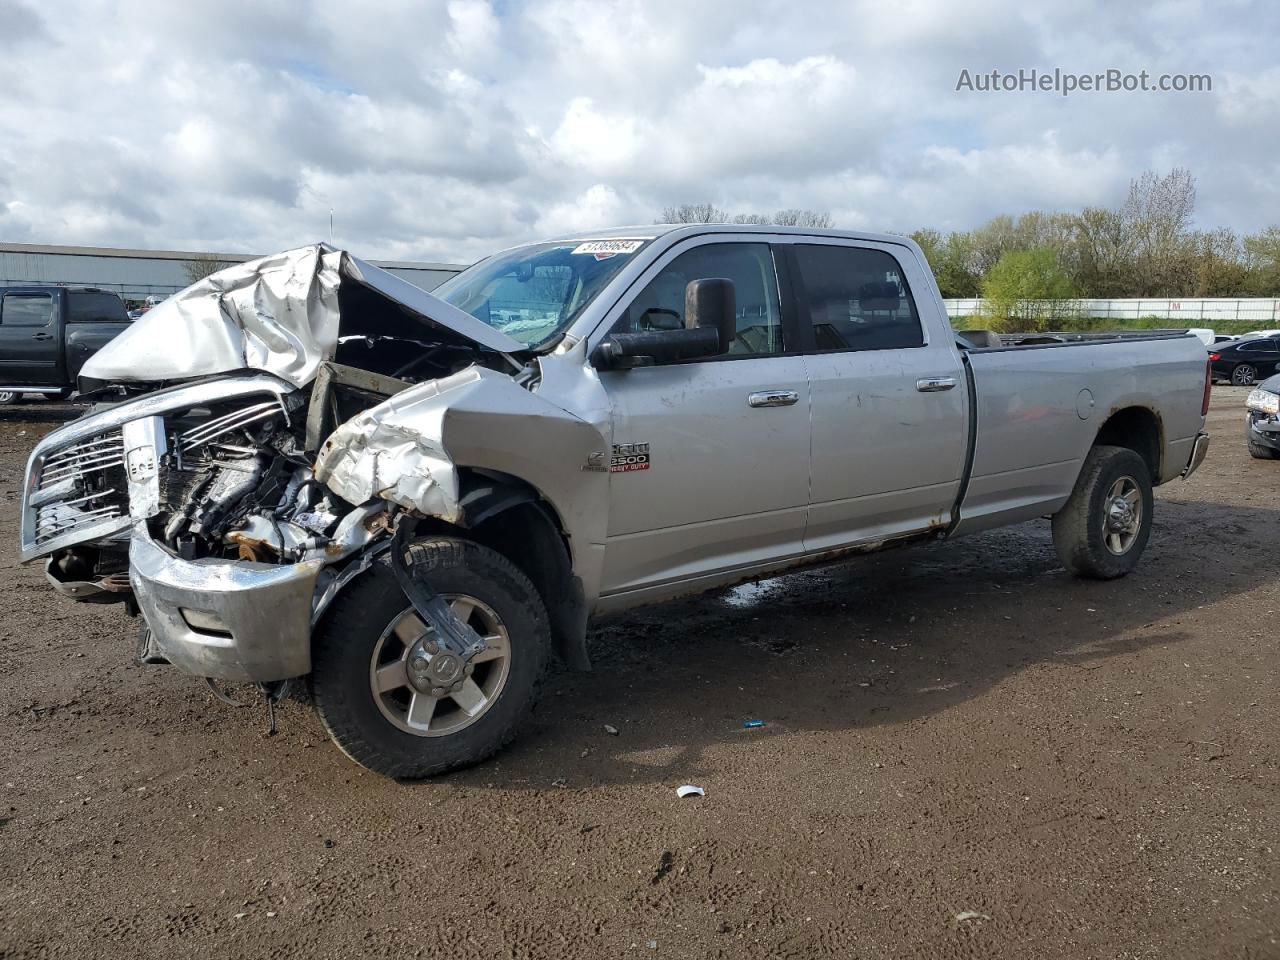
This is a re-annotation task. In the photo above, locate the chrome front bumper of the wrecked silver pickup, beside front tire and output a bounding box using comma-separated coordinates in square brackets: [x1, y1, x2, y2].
[129, 530, 324, 682]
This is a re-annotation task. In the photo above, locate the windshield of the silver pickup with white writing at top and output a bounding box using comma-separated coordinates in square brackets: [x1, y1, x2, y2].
[431, 239, 649, 347]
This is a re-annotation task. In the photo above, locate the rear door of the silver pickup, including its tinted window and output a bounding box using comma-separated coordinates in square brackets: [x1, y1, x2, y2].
[787, 238, 969, 552]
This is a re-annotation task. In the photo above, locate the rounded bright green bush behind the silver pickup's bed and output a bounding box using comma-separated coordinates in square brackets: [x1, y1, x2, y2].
[982, 247, 1076, 333]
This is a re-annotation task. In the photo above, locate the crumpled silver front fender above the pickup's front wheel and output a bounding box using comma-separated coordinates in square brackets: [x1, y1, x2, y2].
[315, 366, 609, 568]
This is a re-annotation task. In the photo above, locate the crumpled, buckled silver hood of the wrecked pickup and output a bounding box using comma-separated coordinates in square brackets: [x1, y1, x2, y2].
[81, 243, 525, 387]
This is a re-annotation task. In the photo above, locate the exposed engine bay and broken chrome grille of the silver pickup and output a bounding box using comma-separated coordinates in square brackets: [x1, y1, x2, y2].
[45, 350, 504, 602]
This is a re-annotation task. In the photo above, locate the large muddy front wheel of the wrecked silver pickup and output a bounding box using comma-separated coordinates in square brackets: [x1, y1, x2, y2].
[308, 538, 550, 780]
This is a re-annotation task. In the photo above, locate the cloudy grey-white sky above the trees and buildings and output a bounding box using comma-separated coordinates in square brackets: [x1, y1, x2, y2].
[0, 0, 1280, 261]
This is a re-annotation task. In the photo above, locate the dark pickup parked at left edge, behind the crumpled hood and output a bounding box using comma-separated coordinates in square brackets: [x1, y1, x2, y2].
[0, 287, 129, 403]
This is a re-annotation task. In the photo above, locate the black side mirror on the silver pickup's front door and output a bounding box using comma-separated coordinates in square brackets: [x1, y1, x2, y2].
[591, 278, 737, 370]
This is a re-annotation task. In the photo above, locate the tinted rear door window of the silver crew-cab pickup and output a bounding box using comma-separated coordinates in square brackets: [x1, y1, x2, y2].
[795, 243, 924, 351]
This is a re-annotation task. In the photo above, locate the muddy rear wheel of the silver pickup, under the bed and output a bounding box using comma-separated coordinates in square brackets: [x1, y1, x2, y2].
[1053, 445, 1155, 580]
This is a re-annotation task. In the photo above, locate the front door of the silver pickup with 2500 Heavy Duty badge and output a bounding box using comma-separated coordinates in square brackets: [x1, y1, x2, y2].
[600, 237, 809, 595]
